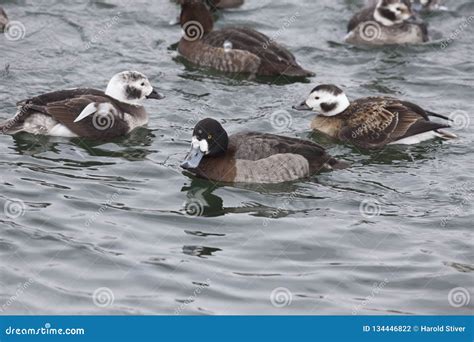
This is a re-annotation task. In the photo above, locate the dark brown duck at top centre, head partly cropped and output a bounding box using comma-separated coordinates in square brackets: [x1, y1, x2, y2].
[178, 0, 314, 77]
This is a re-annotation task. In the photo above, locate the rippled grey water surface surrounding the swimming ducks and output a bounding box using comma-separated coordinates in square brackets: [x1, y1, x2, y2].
[0, 0, 474, 315]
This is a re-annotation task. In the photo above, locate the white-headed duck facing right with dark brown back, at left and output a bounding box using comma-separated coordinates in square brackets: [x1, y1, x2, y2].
[0, 71, 164, 140]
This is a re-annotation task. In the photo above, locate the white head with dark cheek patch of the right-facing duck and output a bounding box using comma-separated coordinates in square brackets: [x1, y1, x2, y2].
[105, 71, 164, 106]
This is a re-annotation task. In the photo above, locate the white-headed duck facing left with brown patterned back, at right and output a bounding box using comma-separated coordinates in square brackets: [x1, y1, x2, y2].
[293, 84, 456, 149]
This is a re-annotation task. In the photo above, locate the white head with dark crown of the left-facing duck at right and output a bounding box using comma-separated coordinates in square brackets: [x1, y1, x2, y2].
[293, 84, 350, 116]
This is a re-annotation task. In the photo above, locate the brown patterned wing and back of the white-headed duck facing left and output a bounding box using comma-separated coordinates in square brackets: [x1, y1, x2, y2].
[339, 97, 449, 148]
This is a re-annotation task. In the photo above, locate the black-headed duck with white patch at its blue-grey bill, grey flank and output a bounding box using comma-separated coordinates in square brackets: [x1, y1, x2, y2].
[181, 118, 348, 183]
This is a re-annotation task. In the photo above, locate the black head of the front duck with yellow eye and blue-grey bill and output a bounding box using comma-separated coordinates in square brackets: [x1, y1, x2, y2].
[181, 118, 229, 169]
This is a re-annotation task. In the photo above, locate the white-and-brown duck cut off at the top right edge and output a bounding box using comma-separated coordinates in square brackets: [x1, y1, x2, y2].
[344, 0, 429, 45]
